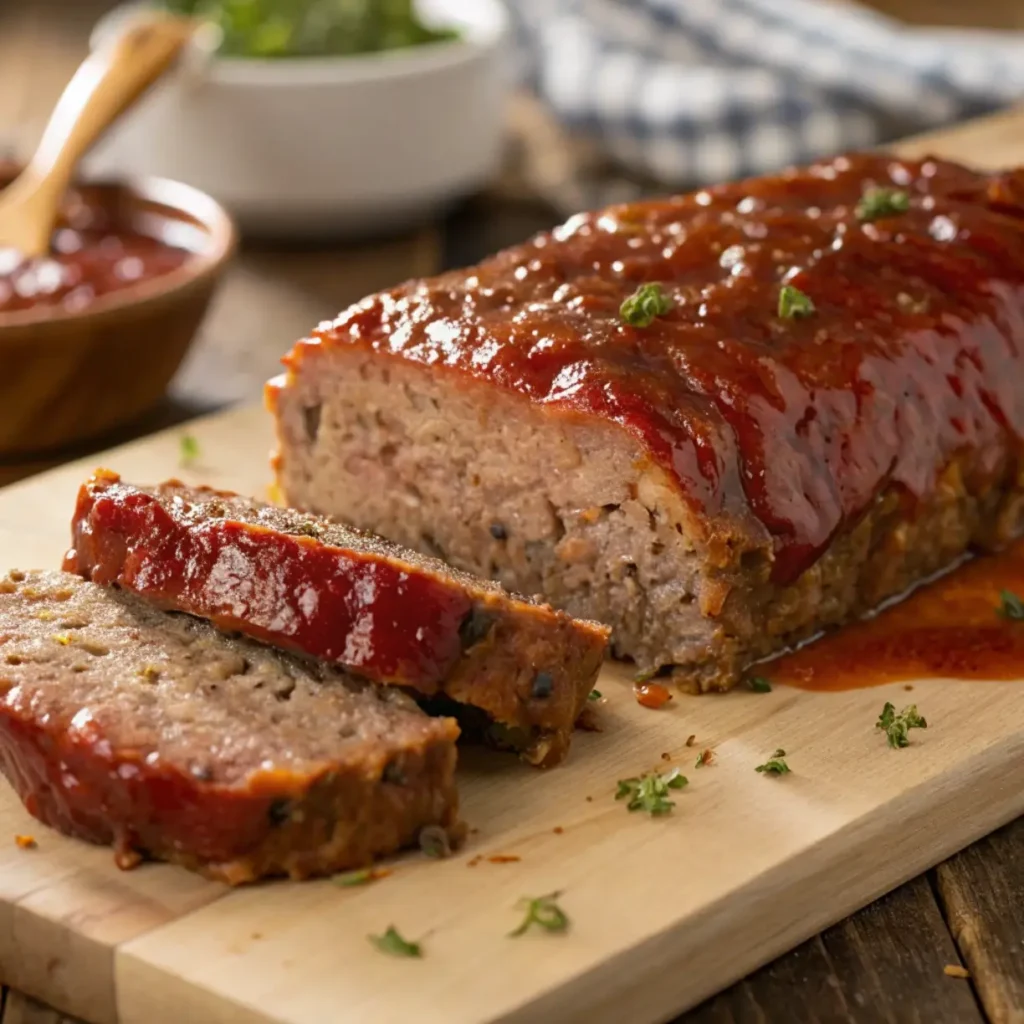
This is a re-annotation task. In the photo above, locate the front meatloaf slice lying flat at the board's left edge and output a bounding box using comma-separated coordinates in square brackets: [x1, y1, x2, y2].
[0, 571, 459, 885]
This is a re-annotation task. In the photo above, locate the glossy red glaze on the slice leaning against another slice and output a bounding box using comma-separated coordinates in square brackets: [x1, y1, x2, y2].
[65, 473, 472, 694]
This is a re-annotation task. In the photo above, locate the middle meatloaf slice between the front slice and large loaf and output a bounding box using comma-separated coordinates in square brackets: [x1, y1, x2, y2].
[65, 470, 608, 766]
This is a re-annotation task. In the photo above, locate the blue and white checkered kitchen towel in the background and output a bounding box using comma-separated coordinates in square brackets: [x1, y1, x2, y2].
[509, 0, 1024, 206]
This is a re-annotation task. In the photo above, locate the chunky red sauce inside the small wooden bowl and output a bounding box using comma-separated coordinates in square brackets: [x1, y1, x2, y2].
[0, 192, 191, 317]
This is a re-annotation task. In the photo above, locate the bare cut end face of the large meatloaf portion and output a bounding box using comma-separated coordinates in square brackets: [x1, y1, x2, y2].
[268, 345, 737, 692]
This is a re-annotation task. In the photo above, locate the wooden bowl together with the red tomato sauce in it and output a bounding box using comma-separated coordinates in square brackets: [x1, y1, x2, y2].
[0, 165, 236, 460]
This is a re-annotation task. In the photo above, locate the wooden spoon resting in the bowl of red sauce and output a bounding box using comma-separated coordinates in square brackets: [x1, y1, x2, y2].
[0, 12, 196, 259]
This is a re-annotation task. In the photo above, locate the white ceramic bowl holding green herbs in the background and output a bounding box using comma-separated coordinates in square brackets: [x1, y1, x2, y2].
[87, 0, 510, 237]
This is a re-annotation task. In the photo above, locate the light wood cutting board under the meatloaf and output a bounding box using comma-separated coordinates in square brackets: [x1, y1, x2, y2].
[0, 105, 1024, 1024]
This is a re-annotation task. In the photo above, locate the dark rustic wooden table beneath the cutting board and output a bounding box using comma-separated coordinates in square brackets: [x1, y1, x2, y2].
[0, 0, 1024, 1024]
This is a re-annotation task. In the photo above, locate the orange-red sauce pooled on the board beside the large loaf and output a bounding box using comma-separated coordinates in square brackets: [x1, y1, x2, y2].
[754, 540, 1024, 690]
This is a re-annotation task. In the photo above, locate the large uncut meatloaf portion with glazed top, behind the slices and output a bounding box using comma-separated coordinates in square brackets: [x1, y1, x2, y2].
[267, 149, 1024, 689]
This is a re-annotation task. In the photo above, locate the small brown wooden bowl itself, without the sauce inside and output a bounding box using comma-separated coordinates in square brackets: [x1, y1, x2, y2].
[0, 167, 236, 459]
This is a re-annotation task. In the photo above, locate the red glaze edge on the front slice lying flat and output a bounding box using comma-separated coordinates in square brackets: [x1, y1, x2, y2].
[0, 686, 292, 866]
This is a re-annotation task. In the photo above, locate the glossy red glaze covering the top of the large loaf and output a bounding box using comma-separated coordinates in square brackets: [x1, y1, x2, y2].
[286, 155, 1024, 583]
